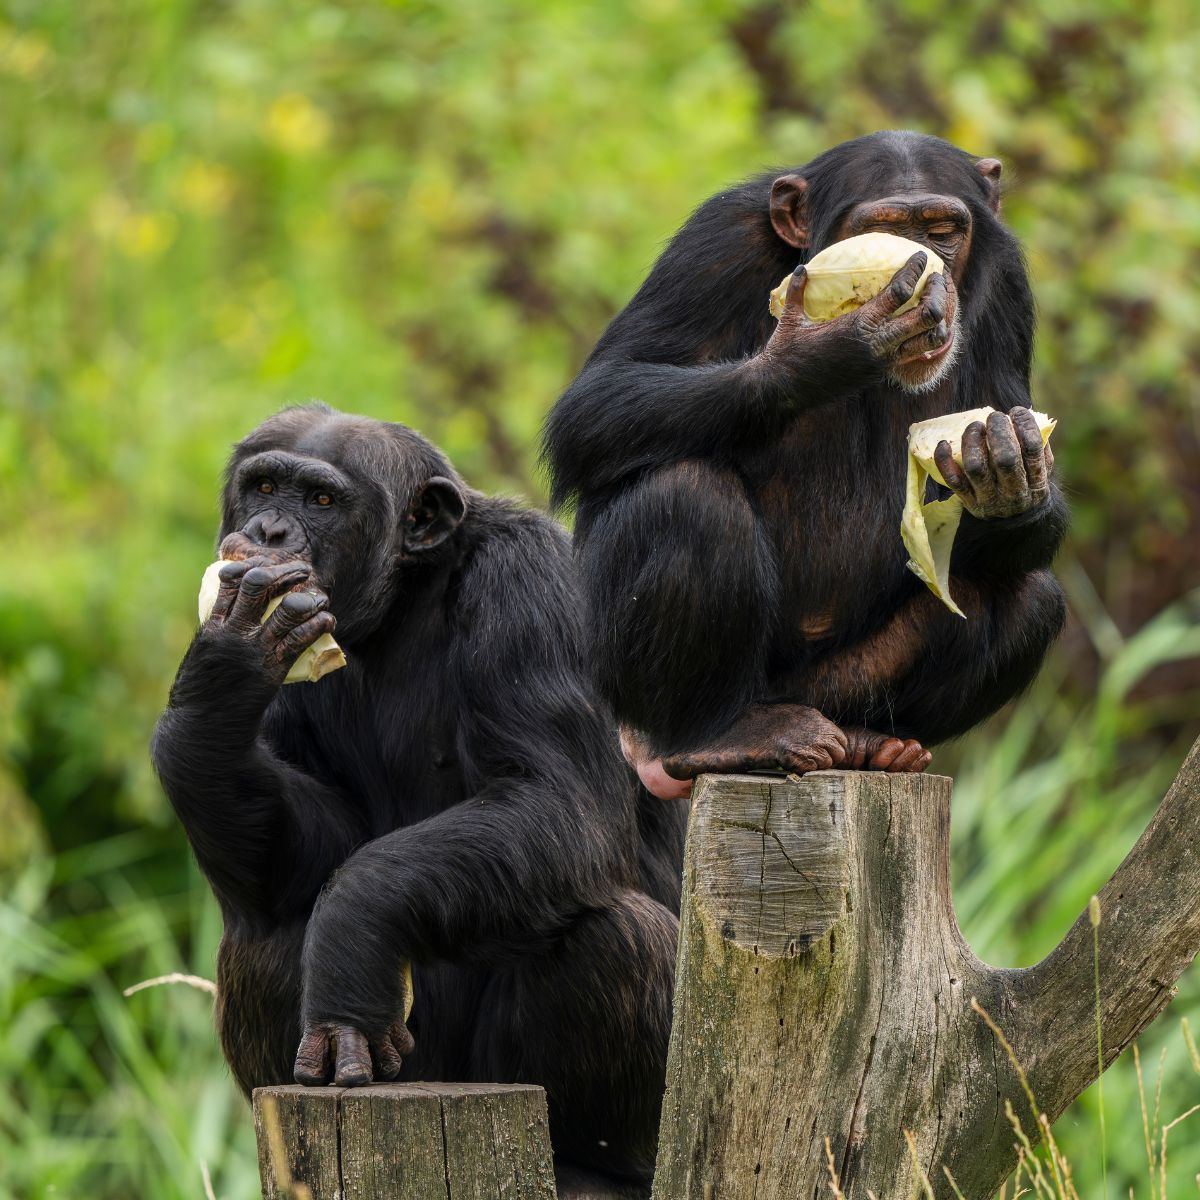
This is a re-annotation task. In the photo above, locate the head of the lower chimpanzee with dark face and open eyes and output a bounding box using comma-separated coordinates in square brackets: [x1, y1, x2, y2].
[220, 404, 468, 644]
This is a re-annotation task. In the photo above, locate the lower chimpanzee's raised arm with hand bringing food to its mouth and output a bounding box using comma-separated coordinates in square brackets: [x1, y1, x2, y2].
[151, 564, 361, 920]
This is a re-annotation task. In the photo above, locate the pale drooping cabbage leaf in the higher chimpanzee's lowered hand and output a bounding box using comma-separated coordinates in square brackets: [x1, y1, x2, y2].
[900, 408, 1058, 617]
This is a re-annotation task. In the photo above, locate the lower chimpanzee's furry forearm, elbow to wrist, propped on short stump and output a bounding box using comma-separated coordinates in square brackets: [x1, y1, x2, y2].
[302, 780, 613, 1034]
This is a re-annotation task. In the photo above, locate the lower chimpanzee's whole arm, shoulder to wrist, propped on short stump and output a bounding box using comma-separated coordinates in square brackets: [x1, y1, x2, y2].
[301, 512, 636, 1056]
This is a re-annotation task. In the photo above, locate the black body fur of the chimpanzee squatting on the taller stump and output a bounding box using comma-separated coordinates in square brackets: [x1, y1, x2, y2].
[545, 132, 1067, 752]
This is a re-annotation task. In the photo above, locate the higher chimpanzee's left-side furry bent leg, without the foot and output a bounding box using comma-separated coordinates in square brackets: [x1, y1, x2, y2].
[575, 461, 778, 754]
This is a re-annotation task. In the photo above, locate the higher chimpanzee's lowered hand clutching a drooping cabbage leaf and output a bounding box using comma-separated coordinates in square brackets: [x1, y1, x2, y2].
[934, 408, 1054, 521]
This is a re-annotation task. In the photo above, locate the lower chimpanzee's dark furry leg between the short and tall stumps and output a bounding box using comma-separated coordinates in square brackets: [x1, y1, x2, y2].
[472, 892, 679, 1181]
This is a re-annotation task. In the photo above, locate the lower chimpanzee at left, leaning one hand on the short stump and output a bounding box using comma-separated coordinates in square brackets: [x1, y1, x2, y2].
[152, 404, 685, 1178]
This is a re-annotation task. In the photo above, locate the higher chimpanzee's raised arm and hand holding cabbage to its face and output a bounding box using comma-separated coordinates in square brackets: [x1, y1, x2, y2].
[545, 196, 946, 504]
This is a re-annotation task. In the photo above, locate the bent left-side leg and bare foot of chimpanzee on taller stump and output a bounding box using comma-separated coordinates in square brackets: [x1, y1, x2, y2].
[576, 461, 845, 797]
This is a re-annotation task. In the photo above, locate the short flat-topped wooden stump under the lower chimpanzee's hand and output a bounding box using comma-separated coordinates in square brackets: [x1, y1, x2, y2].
[254, 1084, 554, 1200]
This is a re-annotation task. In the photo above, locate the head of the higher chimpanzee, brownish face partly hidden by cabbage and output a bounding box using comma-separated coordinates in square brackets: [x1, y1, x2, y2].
[770, 131, 1033, 398]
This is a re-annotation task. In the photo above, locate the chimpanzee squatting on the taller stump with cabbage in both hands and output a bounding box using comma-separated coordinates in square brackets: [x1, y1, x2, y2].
[545, 132, 1067, 796]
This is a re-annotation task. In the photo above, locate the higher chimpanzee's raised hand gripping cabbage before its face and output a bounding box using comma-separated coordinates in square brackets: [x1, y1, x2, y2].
[763, 251, 956, 371]
